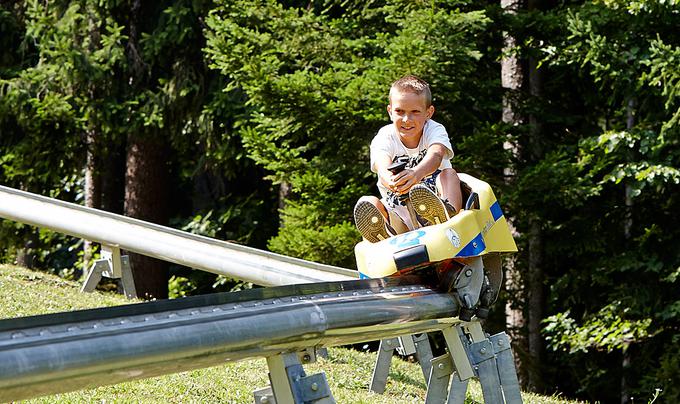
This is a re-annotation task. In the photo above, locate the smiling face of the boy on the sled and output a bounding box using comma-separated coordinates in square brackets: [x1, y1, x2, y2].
[387, 90, 434, 148]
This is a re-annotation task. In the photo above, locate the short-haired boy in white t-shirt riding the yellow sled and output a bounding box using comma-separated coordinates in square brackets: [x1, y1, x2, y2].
[354, 75, 462, 243]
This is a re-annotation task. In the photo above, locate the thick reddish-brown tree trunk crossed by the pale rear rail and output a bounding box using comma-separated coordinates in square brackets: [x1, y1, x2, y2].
[125, 134, 169, 299]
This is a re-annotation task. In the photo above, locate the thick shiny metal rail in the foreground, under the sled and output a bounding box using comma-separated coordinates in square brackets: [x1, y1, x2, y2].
[0, 277, 459, 402]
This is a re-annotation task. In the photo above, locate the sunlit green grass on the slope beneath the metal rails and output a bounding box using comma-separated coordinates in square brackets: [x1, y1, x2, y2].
[0, 265, 584, 404]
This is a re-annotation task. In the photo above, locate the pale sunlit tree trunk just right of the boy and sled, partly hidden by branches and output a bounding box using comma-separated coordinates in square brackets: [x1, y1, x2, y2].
[501, 0, 529, 387]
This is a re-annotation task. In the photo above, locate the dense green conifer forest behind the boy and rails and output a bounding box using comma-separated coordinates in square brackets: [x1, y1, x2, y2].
[0, 0, 680, 403]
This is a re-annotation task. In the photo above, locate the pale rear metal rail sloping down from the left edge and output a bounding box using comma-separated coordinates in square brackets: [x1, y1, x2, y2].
[0, 186, 358, 286]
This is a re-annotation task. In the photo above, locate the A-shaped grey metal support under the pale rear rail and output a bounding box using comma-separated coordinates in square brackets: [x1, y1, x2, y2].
[80, 244, 137, 299]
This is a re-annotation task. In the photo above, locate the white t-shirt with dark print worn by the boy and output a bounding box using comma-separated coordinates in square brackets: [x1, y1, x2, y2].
[371, 119, 453, 205]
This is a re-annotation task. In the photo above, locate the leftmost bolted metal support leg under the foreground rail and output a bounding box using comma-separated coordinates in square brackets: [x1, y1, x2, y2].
[262, 353, 335, 404]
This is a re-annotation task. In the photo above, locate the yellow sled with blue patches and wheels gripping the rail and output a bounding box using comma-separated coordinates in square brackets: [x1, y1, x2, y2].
[354, 173, 517, 321]
